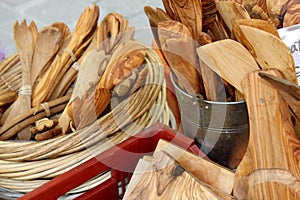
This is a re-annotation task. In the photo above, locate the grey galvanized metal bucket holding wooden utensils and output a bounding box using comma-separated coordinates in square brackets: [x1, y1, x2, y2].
[171, 74, 249, 169]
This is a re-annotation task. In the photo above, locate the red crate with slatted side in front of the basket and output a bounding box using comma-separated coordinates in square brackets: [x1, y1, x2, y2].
[19, 123, 204, 200]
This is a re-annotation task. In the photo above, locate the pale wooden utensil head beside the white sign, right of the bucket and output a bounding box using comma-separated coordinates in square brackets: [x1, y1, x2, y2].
[233, 25, 297, 83]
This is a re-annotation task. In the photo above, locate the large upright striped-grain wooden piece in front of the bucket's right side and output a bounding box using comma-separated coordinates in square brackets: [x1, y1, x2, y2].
[234, 70, 300, 199]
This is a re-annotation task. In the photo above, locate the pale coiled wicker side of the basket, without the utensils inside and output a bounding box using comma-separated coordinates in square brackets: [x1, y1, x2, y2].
[0, 48, 170, 194]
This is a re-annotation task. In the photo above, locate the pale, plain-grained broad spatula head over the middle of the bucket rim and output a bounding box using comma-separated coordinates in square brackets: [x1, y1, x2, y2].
[197, 39, 259, 92]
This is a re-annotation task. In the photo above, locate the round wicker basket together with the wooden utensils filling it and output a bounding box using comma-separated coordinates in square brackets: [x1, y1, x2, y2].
[0, 5, 170, 193]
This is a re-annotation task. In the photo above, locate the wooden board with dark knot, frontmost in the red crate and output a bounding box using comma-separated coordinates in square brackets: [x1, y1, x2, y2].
[127, 151, 218, 200]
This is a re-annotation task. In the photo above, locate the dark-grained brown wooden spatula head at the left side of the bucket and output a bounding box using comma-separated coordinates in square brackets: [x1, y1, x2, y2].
[158, 20, 202, 95]
